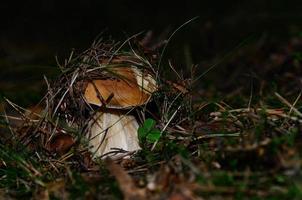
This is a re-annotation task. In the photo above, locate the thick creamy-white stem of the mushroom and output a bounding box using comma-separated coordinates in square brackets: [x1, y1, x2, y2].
[87, 111, 140, 158]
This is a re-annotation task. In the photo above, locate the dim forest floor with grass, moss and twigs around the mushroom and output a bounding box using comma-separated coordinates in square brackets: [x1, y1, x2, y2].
[0, 31, 302, 200]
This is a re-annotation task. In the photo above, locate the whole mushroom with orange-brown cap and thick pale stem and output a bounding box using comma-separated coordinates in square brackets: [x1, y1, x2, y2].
[84, 60, 157, 158]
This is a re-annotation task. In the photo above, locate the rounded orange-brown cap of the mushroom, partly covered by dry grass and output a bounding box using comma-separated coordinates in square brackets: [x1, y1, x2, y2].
[84, 66, 156, 109]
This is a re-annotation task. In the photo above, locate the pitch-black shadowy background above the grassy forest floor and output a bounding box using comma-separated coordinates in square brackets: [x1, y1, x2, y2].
[0, 0, 302, 104]
